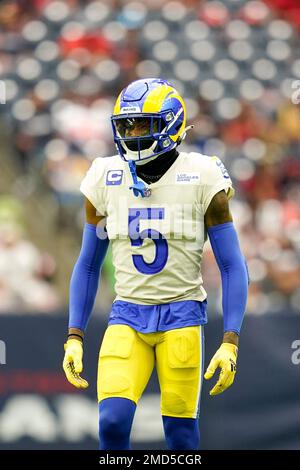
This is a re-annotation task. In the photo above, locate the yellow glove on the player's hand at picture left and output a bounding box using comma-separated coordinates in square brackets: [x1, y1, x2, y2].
[63, 339, 89, 388]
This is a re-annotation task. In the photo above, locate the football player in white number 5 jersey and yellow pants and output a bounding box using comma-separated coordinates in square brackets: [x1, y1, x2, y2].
[63, 79, 248, 449]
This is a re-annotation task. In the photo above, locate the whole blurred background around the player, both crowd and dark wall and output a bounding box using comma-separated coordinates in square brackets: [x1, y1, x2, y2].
[0, 0, 300, 448]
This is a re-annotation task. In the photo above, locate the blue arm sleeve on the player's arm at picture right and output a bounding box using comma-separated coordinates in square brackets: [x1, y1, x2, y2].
[208, 222, 249, 334]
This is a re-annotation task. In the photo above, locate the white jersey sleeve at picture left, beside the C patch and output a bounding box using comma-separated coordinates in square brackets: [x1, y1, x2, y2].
[80, 158, 106, 215]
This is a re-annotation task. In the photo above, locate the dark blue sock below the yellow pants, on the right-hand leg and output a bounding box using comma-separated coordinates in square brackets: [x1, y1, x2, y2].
[162, 416, 200, 450]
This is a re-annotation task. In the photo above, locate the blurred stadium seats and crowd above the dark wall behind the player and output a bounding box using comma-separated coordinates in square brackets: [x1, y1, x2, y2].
[0, 0, 300, 314]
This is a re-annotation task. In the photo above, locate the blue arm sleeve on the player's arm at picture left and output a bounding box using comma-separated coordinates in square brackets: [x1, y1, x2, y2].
[69, 224, 109, 330]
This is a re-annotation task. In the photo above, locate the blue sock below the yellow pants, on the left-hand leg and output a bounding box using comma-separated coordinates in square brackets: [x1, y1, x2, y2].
[99, 398, 136, 450]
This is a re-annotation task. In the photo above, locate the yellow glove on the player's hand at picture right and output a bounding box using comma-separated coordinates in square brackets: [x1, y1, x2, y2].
[204, 343, 238, 395]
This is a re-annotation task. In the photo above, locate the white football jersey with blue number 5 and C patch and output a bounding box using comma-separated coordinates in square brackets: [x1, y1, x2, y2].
[80, 152, 234, 305]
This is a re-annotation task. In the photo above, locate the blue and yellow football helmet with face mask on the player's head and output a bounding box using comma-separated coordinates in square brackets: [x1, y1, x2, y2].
[111, 78, 186, 164]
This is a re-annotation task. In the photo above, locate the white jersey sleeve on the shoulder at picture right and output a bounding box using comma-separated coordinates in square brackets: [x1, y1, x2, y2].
[201, 157, 234, 214]
